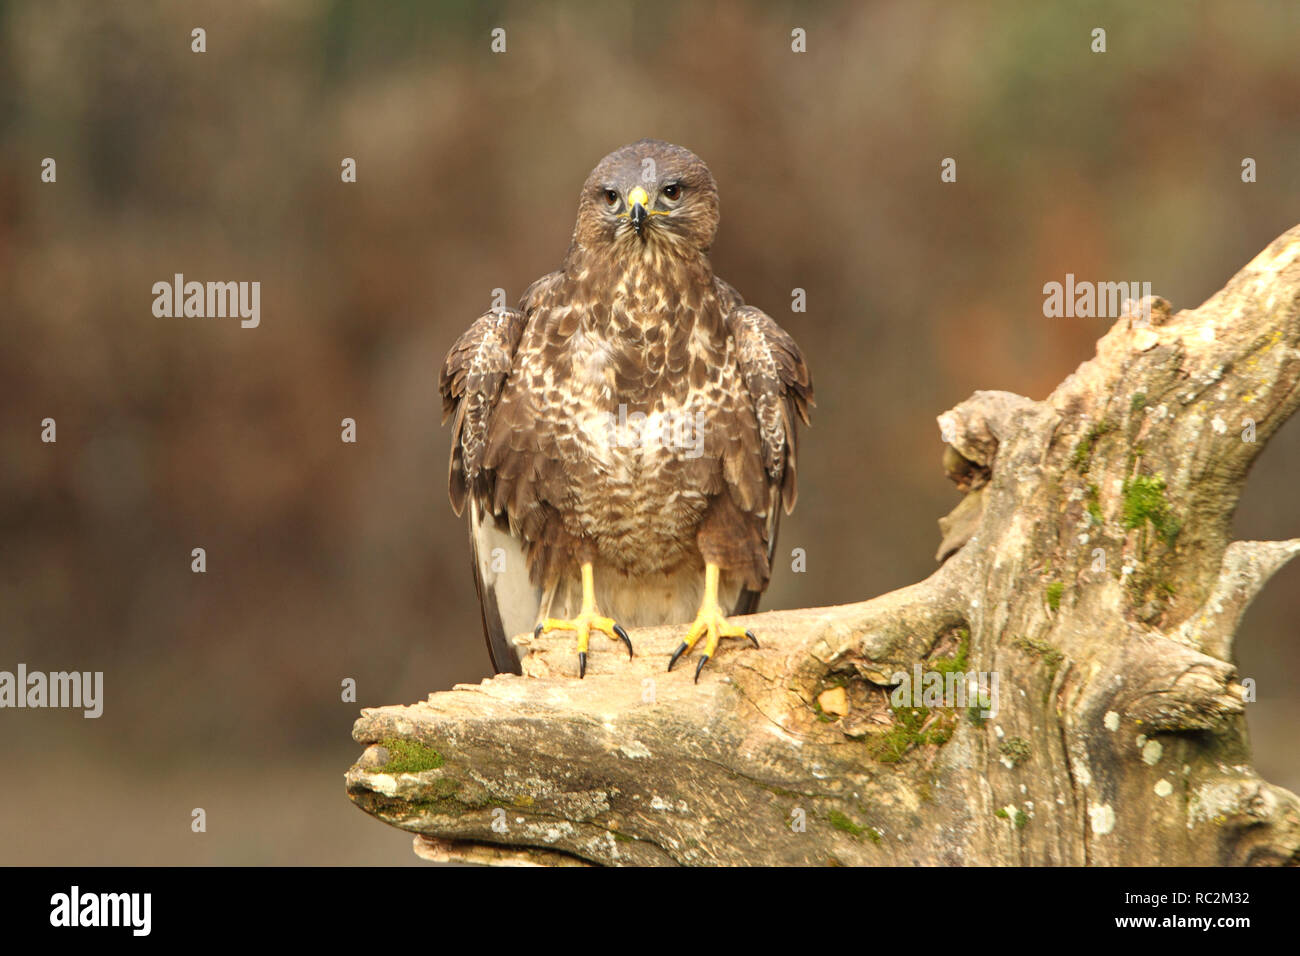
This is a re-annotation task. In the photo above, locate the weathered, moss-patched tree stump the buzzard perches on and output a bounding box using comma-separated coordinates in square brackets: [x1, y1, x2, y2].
[347, 226, 1300, 865]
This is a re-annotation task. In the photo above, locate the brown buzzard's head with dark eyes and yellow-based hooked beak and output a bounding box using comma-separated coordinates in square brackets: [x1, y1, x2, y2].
[573, 139, 718, 256]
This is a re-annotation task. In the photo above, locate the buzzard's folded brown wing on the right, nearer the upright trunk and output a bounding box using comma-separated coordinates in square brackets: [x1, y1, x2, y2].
[718, 280, 816, 614]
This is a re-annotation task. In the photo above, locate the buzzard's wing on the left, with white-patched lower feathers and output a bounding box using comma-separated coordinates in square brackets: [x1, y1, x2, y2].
[438, 293, 541, 674]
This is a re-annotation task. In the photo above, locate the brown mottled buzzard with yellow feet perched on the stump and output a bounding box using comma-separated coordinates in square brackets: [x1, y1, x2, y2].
[438, 139, 814, 682]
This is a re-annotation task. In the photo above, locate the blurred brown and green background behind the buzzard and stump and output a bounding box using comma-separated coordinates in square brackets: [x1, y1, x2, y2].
[0, 0, 1300, 864]
